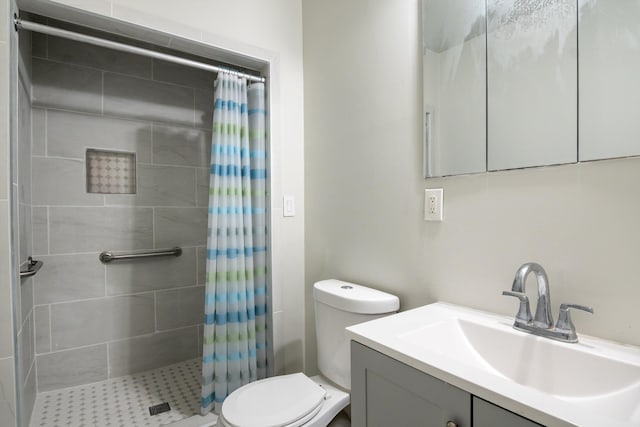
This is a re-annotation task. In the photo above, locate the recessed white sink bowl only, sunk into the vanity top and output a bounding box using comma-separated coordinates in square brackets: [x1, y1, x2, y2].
[400, 319, 640, 398]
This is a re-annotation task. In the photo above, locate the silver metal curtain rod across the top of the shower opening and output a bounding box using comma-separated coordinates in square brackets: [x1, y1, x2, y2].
[13, 18, 266, 83]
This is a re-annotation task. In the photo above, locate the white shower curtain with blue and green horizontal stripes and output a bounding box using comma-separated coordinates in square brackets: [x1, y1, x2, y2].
[201, 73, 267, 414]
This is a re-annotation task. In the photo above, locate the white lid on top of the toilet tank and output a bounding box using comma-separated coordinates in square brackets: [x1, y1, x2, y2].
[313, 279, 400, 314]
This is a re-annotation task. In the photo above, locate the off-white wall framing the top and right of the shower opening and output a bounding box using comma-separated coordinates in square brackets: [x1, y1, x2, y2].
[20, 0, 305, 373]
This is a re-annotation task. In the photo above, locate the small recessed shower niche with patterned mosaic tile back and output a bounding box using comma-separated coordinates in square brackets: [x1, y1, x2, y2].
[86, 148, 136, 194]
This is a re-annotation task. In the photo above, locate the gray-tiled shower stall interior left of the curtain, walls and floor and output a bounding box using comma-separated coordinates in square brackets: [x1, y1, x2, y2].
[14, 7, 268, 427]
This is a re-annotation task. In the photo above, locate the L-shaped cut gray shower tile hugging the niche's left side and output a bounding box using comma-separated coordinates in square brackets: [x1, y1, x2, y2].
[32, 157, 104, 206]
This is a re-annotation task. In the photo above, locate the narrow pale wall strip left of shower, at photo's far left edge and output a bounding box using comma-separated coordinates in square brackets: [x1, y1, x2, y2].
[0, 0, 16, 427]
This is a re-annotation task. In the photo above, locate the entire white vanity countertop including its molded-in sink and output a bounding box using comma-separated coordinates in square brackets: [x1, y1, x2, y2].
[347, 303, 640, 427]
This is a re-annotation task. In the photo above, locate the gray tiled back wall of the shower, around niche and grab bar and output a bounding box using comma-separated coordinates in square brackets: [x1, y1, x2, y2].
[32, 23, 215, 392]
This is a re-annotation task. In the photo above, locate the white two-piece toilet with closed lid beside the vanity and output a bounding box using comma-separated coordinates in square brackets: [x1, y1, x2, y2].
[217, 279, 400, 427]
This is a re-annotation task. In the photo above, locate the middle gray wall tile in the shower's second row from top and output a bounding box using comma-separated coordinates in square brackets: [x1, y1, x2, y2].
[104, 73, 194, 126]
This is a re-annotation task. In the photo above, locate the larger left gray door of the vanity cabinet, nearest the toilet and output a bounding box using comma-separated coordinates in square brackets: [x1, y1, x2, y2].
[351, 341, 472, 427]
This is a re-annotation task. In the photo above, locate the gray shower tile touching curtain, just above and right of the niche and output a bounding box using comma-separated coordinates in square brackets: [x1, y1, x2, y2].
[153, 124, 211, 167]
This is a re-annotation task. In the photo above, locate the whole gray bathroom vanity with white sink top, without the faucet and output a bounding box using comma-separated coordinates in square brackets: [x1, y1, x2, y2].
[346, 303, 640, 427]
